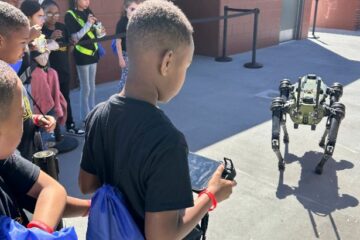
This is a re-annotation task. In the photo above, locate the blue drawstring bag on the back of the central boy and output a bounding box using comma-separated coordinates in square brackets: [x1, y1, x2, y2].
[86, 185, 144, 240]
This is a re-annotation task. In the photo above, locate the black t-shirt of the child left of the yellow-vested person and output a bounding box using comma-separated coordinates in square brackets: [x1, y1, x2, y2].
[42, 22, 70, 73]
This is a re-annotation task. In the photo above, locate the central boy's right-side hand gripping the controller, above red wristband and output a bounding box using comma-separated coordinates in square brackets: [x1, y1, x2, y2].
[207, 164, 236, 202]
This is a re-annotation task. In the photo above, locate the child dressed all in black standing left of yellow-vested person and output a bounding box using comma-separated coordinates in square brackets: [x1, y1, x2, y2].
[41, 0, 85, 136]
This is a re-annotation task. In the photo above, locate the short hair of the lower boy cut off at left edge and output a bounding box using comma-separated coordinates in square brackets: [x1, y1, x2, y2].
[0, 60, 18, 122]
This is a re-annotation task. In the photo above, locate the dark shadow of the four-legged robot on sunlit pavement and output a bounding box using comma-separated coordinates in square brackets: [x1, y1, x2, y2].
[276, 151, 359, 240]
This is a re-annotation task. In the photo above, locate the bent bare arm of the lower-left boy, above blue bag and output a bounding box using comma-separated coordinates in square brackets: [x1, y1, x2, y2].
[27, 171, 66, 228]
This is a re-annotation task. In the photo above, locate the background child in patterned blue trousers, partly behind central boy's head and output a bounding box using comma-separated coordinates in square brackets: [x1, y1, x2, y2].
[116, 0, 142, 92]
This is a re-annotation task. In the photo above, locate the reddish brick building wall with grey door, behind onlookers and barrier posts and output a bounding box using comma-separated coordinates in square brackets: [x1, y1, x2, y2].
[57, 0, 313, 85]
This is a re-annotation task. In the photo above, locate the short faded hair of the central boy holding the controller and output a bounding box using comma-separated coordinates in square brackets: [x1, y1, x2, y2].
[126, 0, 193, 53]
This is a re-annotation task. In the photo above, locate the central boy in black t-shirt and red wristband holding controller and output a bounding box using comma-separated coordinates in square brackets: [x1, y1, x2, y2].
[79, 0, 235, 239]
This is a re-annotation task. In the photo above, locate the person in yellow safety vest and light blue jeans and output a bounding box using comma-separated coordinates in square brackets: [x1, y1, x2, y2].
[65, 0, 105, 121]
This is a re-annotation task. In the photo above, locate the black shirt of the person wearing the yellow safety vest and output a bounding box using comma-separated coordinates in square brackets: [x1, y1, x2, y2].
[65, 9, 99, 65]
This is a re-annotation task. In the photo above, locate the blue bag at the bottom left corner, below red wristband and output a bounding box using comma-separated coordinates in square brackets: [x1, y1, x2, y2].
[0, 216, 78, 240]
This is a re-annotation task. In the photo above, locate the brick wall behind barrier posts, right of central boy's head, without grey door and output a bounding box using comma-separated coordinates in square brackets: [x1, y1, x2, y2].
[176, 0, 311, 56]
